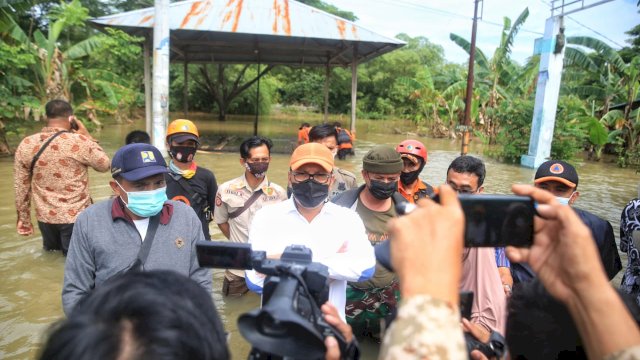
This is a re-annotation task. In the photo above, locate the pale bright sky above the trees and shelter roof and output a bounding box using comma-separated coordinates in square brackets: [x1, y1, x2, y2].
[325, 0, 640, 64]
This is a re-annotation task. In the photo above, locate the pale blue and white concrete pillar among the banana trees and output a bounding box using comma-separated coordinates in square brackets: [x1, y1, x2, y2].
[520, 16, 564, 168]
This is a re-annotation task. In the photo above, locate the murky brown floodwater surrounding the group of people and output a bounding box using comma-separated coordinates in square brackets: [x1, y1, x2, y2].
[0, 116, 640, 359]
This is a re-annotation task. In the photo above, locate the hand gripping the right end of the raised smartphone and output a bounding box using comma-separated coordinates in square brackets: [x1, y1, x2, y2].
[506, 185, 609, 303]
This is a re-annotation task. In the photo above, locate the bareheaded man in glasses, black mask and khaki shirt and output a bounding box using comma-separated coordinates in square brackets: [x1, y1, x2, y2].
[213, 136, 287, 296]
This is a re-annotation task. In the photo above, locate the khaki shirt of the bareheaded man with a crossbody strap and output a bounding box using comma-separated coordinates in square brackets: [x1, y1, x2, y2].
[213, 174, 287, 277]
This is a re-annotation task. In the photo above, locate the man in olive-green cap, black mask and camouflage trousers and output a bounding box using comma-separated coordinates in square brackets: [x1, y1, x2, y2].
[332, 145, 406, 341]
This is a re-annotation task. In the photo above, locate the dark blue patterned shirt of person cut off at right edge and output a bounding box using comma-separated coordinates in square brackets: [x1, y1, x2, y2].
[620, 199, 640, 304]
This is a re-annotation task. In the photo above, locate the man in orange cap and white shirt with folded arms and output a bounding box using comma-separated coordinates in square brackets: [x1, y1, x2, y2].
[246, 143, 375, 320]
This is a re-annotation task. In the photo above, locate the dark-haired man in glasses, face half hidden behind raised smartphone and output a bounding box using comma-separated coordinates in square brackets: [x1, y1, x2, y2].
[447, 155, 513, 295]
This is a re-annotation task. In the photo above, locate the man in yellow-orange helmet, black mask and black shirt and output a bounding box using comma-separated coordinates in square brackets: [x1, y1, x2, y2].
[165, 119, 218, 240]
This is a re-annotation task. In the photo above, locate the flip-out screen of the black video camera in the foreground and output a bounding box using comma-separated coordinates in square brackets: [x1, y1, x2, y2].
[196, 241, 251, 269]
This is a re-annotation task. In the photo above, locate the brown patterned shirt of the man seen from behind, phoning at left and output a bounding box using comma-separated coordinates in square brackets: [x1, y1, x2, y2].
[13, 127, 111, 224]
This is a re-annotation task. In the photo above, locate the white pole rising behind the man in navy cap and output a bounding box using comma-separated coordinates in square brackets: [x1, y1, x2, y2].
[150, 0, 169, 154]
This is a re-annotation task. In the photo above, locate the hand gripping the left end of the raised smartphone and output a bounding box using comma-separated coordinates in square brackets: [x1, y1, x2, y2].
[388, 185, 464, 306]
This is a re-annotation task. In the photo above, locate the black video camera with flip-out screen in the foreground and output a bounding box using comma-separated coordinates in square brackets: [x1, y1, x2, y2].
[196, 241, 356, 359]
